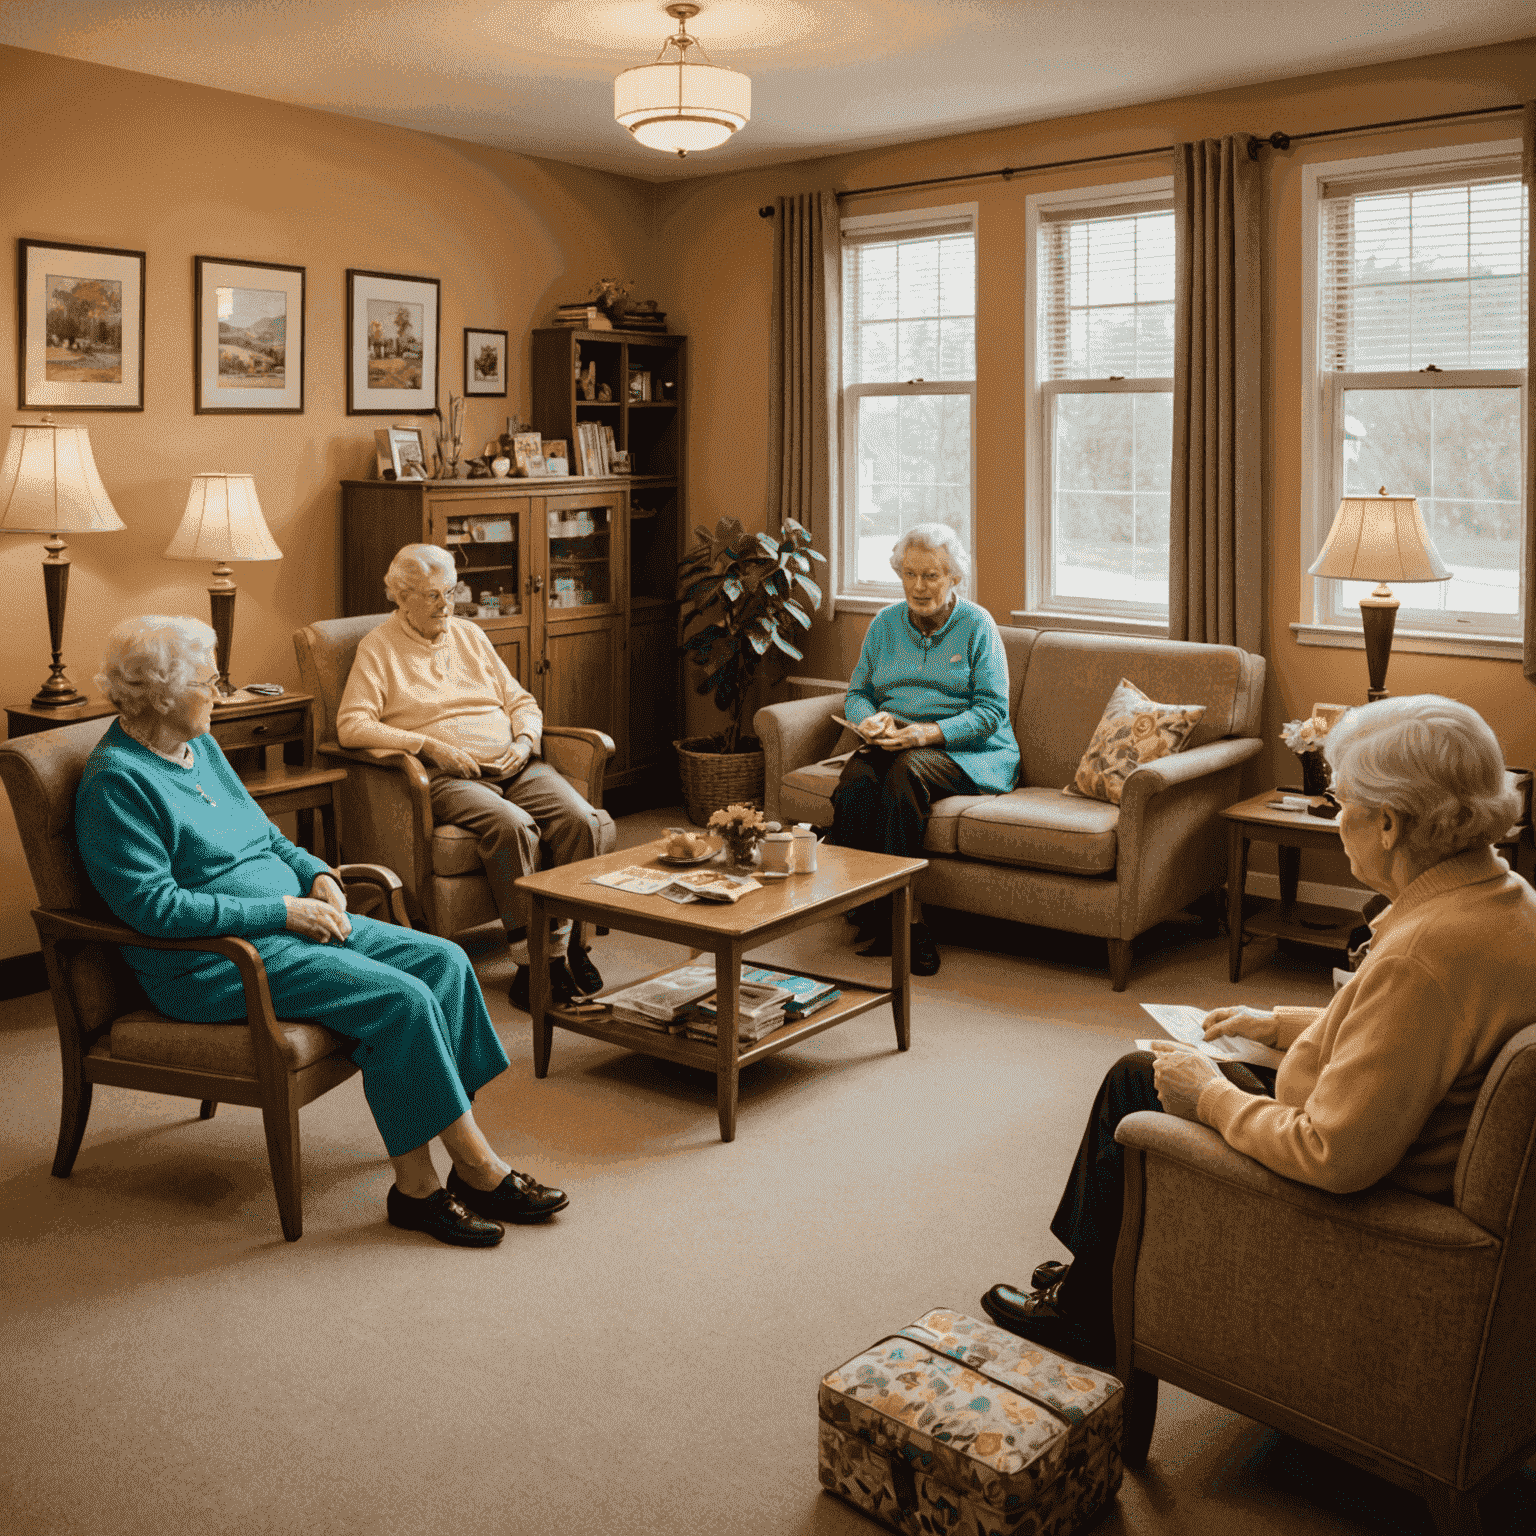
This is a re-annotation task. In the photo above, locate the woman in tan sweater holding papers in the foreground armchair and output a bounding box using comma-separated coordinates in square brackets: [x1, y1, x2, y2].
[982, 694, 1536, 1364]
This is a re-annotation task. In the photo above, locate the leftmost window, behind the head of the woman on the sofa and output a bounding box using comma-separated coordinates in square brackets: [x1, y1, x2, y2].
[839, 207, 975, 602]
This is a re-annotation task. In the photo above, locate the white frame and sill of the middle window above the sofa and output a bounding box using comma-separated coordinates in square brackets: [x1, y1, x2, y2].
[1009, 177, 1174, 636]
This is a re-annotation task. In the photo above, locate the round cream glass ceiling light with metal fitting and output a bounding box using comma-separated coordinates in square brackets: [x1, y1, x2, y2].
[613, 3, 753, 158]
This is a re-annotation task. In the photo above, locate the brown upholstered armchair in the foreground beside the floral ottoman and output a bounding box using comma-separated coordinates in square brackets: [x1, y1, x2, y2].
[1115, 1025, 1536, 1536]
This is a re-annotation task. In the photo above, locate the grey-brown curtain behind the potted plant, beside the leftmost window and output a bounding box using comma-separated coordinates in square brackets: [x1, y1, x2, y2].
[768, 192, 843, 617]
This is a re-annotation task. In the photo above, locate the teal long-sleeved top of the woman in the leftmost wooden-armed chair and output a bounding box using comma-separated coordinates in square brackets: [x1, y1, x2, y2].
[75, 720, 327, 1014]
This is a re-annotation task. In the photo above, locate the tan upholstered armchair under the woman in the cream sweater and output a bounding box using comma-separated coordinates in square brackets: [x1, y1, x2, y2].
[293, 613, 613, 938]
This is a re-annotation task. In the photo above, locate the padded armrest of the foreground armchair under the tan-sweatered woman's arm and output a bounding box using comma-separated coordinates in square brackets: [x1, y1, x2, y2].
[1115, 1111, 1496, 1249]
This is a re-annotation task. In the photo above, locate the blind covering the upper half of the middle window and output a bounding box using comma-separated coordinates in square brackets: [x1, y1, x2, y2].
[1040, 201, 1174, 379]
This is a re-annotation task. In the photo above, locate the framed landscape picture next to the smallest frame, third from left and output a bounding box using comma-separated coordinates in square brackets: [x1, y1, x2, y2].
[347, 267, 439, 416]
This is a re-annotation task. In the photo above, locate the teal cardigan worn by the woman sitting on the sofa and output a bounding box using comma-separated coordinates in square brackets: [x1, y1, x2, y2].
[845, 598, 1018, 794]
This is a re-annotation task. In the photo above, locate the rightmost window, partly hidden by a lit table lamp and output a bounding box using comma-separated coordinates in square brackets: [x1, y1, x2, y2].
[1303, 146, 1530, 637]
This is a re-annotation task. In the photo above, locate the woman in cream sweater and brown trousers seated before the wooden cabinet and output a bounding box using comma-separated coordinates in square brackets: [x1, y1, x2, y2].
[336, 544, 614, 1011]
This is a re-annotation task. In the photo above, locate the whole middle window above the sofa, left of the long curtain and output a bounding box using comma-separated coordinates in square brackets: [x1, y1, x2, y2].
[1026, 178, 1174, 625]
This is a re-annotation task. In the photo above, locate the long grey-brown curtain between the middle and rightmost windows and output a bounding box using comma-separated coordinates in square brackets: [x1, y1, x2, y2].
[1167, 137, 1264, 654]
